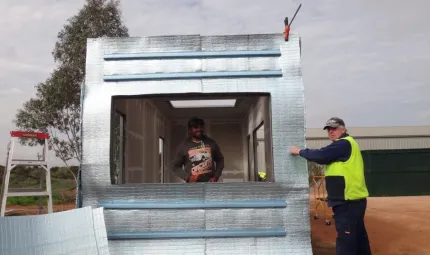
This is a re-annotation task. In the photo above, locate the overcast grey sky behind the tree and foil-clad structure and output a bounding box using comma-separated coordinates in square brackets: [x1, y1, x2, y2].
[0, 0, 430, 164]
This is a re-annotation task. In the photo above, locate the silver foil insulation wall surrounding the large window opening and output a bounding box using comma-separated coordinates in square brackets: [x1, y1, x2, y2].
[79, 34, 312, 254]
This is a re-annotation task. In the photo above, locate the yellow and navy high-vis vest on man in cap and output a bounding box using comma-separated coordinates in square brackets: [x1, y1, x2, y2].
[325, 136, 369, 200]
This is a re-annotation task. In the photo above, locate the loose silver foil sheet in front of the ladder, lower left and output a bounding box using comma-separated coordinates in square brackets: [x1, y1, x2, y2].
[0, 207, 109, 255]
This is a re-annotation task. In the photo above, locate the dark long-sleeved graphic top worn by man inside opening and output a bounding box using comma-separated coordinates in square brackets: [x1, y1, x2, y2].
[173, 137, 224, 182]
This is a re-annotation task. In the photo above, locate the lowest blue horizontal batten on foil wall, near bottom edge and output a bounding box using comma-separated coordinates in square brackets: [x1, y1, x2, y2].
[107, 228, 287, 240]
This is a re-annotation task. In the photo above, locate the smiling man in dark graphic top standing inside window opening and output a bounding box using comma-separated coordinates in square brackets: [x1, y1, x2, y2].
[173, 117, 224, 182]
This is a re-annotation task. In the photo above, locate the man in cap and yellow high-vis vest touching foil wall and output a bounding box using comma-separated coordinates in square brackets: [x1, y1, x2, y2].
[290, 117, 372, 255]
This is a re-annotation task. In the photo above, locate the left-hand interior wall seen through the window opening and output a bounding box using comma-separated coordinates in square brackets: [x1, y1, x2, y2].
[116, 99, 170, 183]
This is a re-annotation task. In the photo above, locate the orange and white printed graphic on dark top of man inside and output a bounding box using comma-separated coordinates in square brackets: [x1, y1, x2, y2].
[188, 146, 213, 175]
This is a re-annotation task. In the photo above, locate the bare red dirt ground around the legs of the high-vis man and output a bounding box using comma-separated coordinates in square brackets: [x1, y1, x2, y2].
[310, 196, 430, 255]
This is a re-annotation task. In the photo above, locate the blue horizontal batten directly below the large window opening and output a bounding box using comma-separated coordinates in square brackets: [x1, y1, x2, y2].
[98, 200, 287, 209]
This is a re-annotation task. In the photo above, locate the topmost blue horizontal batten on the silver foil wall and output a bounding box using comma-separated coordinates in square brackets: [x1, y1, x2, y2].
[104, 50, 281, 61]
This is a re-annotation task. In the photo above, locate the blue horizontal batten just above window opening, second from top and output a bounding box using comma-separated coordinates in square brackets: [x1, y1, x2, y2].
[103, 70, 282, 81]
